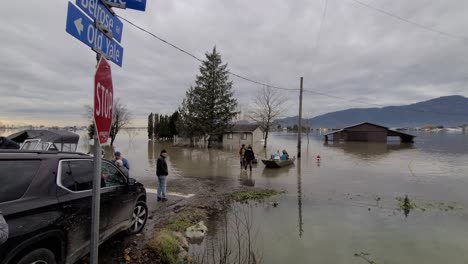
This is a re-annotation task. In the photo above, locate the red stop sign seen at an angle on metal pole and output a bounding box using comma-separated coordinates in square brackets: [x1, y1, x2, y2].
[94, 56, 113, 144]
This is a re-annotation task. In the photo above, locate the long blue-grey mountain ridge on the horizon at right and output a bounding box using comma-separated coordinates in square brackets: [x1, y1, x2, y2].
[276, 95, 468, 128]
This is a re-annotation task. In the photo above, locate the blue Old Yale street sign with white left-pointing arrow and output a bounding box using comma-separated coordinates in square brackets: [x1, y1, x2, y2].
[66, 2, 123, 67]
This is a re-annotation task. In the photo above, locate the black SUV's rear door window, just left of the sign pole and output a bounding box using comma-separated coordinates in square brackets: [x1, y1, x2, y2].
[60, 160, 94, 192]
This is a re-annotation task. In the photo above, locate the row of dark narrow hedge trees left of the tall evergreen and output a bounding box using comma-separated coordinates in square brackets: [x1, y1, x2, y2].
[148, 111, 179, 140]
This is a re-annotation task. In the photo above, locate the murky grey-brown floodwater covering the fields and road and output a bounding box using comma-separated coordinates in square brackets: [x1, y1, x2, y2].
[4, 129, 468, 264]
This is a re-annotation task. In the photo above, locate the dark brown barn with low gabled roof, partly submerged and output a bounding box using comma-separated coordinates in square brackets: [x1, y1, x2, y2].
[323, 122, 415, 142]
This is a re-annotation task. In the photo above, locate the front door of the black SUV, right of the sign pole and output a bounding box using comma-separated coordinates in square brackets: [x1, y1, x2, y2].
[101, 161, 136, 232]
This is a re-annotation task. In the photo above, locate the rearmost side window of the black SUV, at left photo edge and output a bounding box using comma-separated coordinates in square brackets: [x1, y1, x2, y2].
[0, 160, 41, 203]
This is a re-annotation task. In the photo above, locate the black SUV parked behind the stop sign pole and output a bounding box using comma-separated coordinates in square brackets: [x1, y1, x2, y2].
[0, 150, 148, 264]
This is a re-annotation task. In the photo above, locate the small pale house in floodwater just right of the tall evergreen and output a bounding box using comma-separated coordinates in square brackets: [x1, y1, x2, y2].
[223, 124, 263, 146]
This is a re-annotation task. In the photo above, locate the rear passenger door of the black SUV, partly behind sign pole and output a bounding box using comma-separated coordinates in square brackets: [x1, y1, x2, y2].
[57, 159, 109, 259]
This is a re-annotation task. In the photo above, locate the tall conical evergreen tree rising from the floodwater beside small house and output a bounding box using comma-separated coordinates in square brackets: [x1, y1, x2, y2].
[181, 47, 238, 147]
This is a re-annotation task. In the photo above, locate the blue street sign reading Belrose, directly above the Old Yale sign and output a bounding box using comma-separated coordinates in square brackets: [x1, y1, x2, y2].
[76, 0, 123, 42]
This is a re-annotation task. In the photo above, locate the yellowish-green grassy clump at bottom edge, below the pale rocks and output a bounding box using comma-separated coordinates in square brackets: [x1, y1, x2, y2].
[148, 229, 180, 264]
